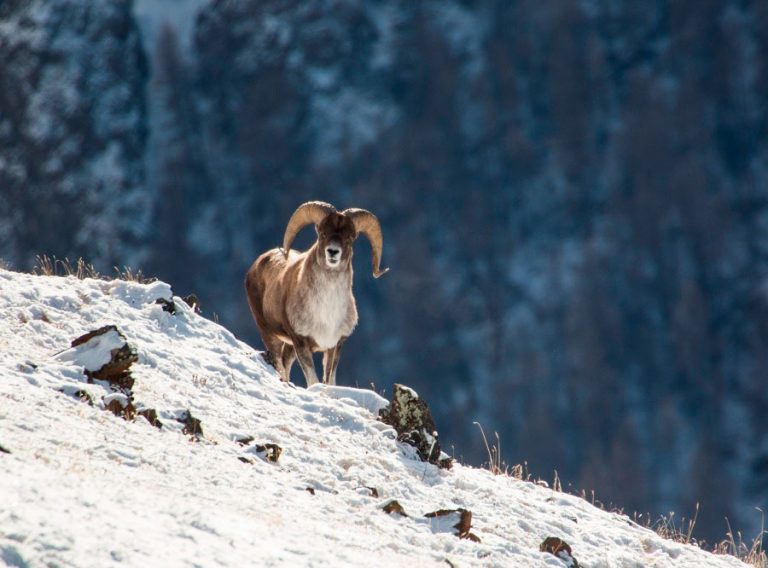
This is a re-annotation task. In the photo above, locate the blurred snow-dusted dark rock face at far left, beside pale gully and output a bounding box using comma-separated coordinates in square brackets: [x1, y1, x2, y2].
[0, 0, 148, 266]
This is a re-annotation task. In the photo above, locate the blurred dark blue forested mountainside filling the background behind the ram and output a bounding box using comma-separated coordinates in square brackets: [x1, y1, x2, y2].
[0, 0, 768, 542]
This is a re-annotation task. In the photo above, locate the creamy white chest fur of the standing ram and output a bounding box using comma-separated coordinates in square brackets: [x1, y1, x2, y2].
[294, 279, 357, 350]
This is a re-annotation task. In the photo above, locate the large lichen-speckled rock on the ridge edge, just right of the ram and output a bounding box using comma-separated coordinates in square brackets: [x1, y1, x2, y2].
[379, 383, 453, 469]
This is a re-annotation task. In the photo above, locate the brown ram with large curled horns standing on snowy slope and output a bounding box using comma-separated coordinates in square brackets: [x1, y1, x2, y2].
[245, 201, 389, 386]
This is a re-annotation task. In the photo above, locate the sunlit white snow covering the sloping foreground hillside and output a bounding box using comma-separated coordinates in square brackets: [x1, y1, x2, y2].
[0, 270, 744, 568]
